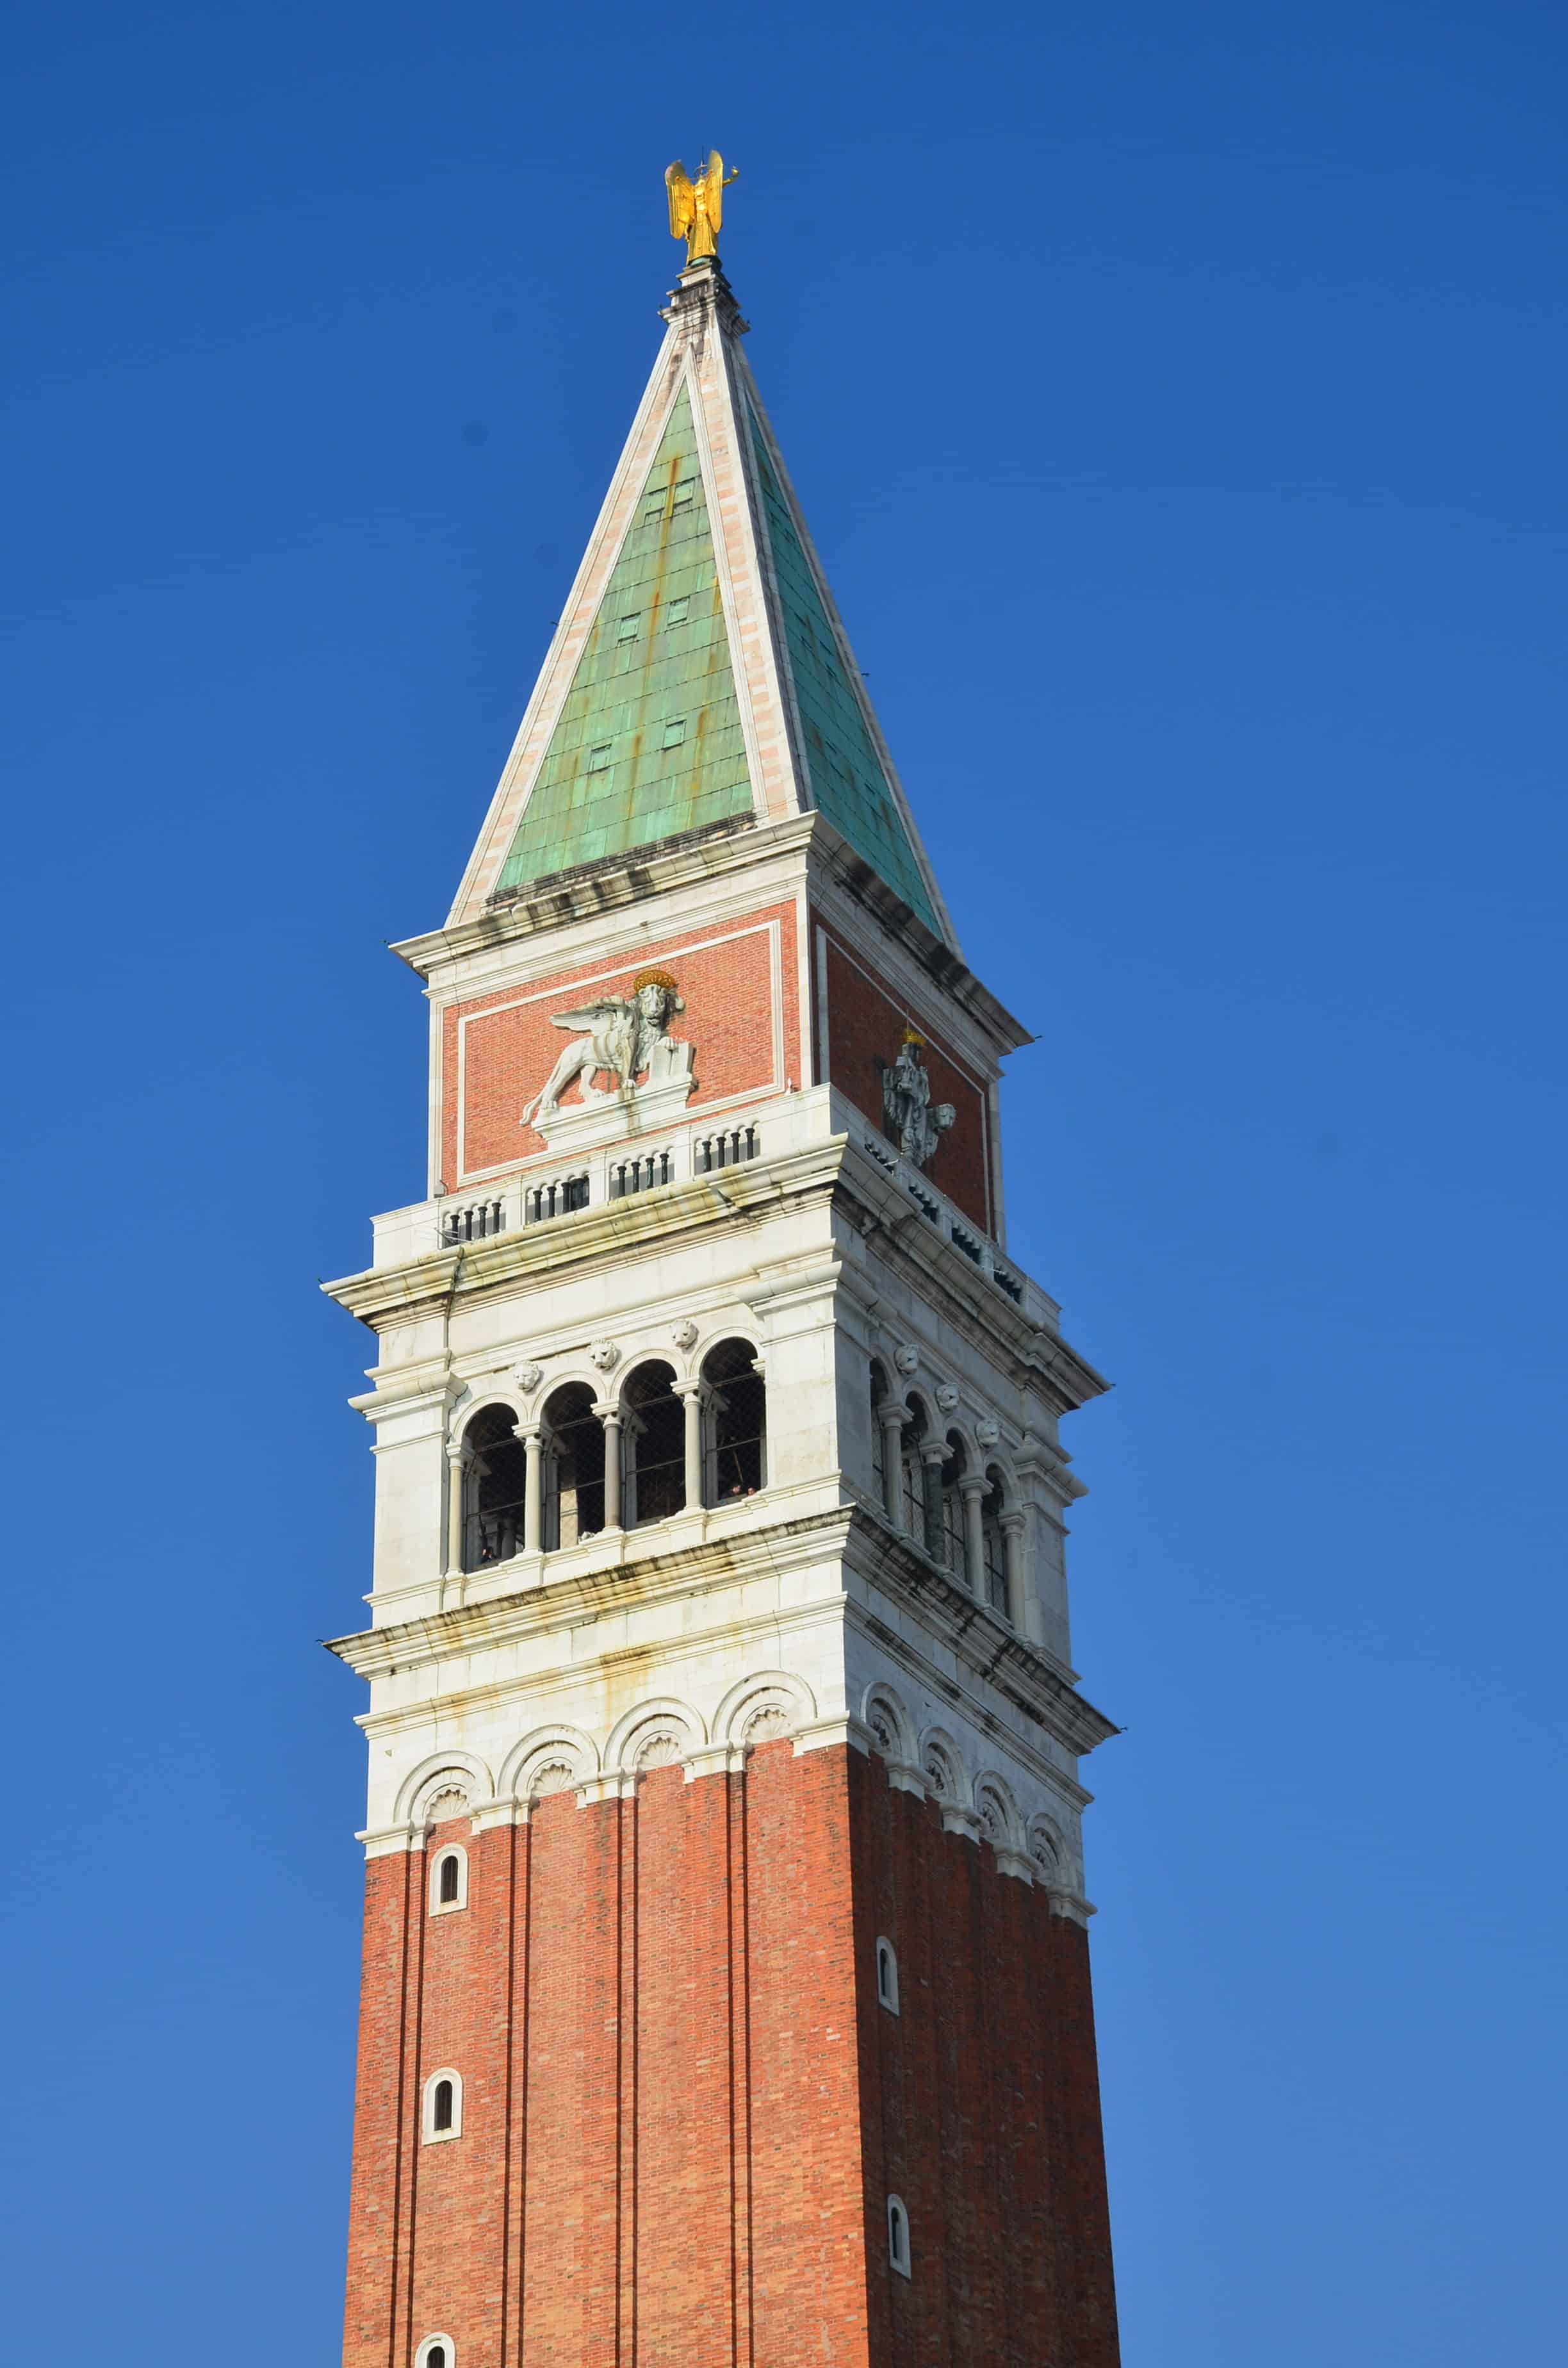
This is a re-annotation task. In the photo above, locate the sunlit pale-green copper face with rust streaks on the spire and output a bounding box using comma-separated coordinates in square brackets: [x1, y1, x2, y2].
[498, 388, 753, 888]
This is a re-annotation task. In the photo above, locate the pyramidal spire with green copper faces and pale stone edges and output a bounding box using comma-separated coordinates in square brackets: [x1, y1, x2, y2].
[450, 253, 957, 950]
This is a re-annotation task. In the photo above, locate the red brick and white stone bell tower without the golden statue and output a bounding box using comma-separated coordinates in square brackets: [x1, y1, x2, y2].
[327, 231, 1118, 2368]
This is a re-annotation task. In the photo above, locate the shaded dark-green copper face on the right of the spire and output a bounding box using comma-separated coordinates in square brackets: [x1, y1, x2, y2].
[751, 412, 943, 938]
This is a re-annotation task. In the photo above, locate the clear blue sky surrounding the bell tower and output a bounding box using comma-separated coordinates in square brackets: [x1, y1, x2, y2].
[0, 0, 1568, 2368]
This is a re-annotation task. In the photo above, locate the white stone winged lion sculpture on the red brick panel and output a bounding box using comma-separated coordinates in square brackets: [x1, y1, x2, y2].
[519, 971, 696, 1149]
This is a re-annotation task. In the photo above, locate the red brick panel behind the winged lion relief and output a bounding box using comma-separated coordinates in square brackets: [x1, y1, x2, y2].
[441, 905, 801, 1187]
